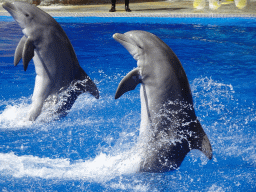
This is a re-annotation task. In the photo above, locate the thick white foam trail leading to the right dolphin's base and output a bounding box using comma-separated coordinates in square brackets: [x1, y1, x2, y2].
[0, 153, 140, 183]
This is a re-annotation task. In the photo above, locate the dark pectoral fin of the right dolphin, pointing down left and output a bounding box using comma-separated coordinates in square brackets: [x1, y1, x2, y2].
[115, 68, 141, 99]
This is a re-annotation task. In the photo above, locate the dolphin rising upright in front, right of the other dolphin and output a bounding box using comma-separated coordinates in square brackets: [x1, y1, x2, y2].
[113, 31, 212, 172]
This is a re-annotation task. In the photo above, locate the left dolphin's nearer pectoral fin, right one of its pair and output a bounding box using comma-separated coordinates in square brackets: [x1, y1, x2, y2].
[22, 38, 35, 71]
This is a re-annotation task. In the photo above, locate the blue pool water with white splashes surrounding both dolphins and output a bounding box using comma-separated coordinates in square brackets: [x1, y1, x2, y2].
[0, 17, 256, 192]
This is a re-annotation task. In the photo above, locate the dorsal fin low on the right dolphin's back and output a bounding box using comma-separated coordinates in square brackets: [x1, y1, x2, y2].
[190, 120, 212, 159]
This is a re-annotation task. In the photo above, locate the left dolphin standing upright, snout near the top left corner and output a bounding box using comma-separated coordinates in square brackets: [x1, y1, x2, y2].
[2, 2, 99, 121]
